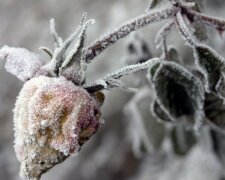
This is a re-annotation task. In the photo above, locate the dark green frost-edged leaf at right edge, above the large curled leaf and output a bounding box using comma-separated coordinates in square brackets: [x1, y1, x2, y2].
[194, 44, 225, 92]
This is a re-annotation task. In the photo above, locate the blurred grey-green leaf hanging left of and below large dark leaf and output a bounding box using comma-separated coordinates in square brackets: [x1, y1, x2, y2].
[124, 87, 164, 157]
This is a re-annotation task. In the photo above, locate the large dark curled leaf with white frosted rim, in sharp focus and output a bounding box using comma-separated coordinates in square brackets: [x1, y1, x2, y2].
[150, 62, 204, 130]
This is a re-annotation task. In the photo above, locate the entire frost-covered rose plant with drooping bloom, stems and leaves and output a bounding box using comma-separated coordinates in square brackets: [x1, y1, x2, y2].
[0, 0, 225, 179]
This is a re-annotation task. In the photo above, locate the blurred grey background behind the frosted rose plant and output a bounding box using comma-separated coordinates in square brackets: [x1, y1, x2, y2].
[0, 0, 225, 180]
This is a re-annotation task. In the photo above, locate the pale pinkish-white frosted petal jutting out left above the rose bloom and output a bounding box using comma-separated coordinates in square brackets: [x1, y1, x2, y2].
[0, 46, 44, 81]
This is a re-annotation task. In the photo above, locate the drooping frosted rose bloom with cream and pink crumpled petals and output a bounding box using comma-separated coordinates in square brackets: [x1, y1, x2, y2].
[14, 76, 101, 179]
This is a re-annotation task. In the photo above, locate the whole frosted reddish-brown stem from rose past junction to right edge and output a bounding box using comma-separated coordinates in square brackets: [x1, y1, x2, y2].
[84, 0, 225, 63]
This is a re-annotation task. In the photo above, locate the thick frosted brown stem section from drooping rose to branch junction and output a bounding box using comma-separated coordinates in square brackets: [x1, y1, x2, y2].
[84, 6, 179, 62]
